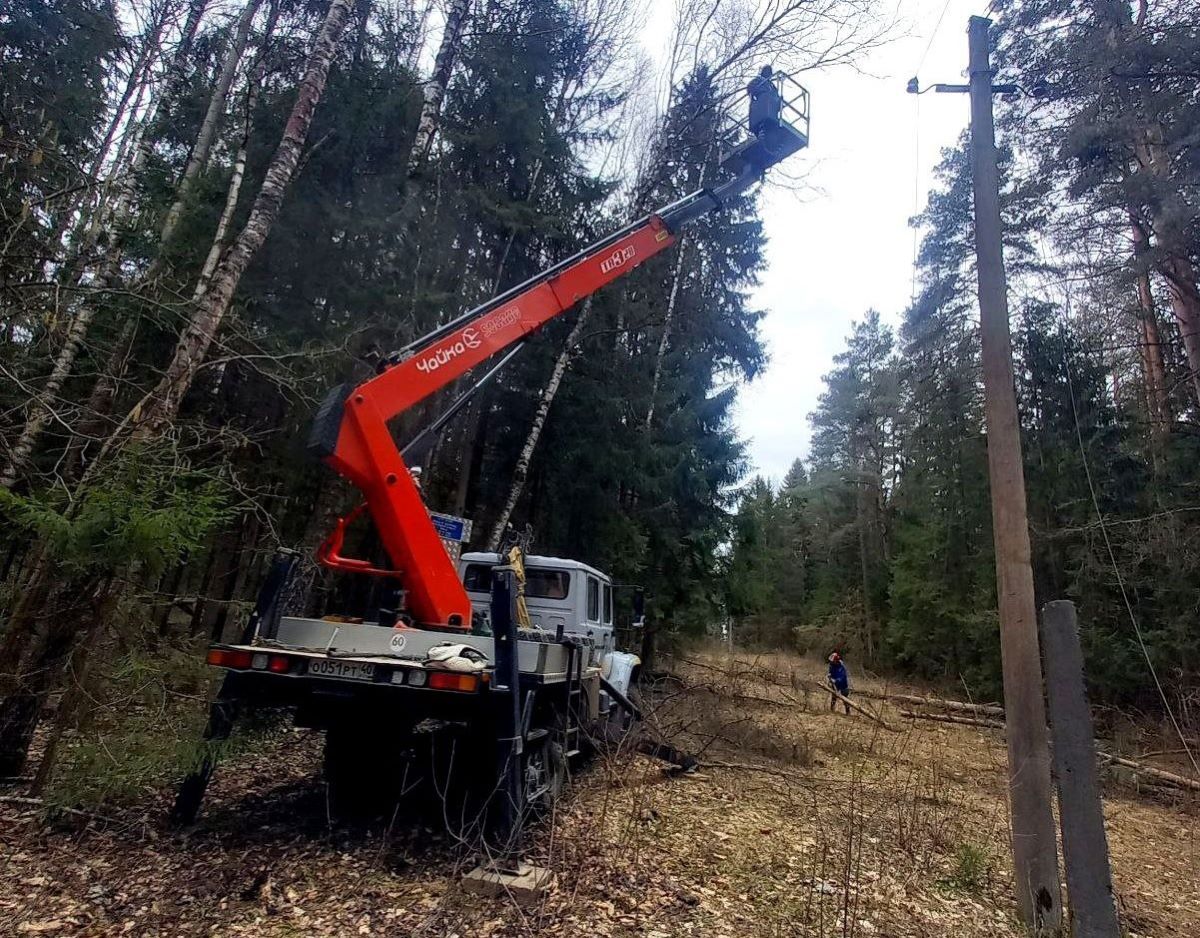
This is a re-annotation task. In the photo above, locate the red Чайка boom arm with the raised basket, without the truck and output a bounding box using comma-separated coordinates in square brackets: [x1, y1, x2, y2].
[310, 70, 808, 631]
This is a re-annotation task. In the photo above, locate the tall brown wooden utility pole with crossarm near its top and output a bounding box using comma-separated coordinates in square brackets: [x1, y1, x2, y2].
[968, 17, 1062, 930]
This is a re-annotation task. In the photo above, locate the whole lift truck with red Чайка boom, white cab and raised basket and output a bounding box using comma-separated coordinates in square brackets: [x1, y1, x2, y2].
[173, 67, 809, 846]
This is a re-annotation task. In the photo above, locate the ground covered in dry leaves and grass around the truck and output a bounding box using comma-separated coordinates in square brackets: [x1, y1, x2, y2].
[0, 655, 1200, 938]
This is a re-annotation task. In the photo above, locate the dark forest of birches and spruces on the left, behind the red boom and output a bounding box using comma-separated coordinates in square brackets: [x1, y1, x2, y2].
[0, 0, 892, 787]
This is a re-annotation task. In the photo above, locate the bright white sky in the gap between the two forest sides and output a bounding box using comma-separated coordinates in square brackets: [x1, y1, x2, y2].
[643, 0, 988, 481]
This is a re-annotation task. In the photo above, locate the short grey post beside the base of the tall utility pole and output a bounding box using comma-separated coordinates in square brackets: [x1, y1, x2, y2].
[1042, 600, 1121, 938]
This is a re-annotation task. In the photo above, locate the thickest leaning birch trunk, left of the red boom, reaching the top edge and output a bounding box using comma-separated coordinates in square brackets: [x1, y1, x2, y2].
[128, 0, 353, 438]
